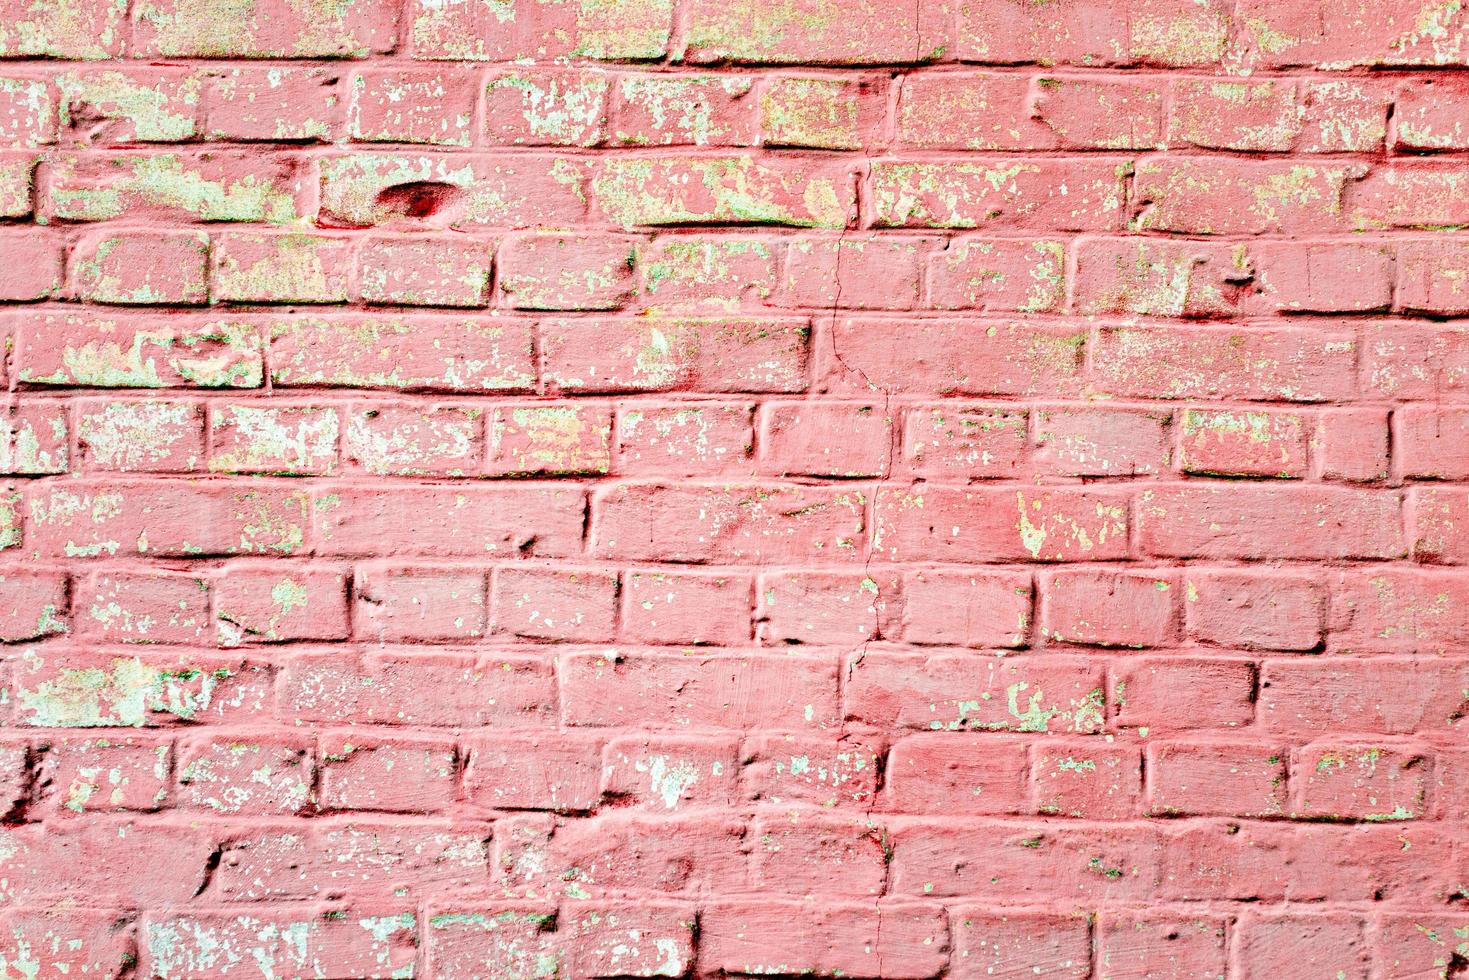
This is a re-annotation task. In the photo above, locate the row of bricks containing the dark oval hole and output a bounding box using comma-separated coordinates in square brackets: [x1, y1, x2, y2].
[14, 148, 1469, 237]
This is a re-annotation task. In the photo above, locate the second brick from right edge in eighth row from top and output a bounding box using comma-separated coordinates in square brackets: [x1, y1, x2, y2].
[1184, 572, 1325, 651]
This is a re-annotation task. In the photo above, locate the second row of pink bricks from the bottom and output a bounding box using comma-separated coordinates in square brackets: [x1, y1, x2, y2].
[0, 811, 1469, 905]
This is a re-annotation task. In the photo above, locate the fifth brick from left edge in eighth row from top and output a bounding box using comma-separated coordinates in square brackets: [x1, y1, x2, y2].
[494, 569, 617, 642]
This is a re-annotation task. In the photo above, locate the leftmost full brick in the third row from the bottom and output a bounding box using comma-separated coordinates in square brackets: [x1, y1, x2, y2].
[38, 736, 173, 814]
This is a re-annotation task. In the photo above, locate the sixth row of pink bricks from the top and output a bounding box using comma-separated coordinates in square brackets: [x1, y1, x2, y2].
[0, 398, 1445, 482]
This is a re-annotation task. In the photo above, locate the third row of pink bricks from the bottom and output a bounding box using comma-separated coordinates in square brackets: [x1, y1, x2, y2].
[0, 730, 1445, 822]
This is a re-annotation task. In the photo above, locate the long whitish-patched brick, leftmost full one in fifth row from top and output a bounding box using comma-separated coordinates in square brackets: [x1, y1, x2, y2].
[16, 313, 264, 388]
